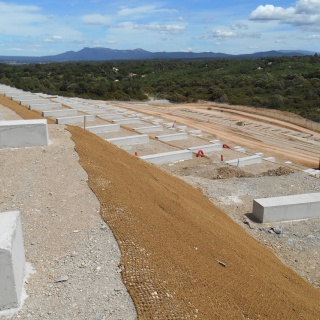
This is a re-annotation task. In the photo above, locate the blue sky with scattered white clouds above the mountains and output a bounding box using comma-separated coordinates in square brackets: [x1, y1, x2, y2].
[0, 0, 320, 56]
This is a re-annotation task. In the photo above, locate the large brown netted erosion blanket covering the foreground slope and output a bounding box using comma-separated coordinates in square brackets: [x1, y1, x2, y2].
[69, 126, 320, 320]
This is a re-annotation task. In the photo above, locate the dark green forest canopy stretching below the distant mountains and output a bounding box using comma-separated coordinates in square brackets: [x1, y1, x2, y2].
[0, 54, 320, 122]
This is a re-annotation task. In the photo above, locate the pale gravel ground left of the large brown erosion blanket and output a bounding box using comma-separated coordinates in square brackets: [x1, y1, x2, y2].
[0, 107, 137, 320]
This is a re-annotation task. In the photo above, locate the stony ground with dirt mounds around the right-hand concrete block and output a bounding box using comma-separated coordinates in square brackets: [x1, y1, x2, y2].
[163, 159, 320, 289]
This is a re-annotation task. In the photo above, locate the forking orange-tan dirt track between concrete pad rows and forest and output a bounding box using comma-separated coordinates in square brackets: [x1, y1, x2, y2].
[110, 102, 320, 168]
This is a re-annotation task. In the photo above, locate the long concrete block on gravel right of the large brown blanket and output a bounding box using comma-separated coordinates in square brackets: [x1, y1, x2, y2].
[252, 193, 320, 223]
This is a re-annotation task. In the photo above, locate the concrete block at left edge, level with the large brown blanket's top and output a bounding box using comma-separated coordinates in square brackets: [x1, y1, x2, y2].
[0, 119, 49, 149]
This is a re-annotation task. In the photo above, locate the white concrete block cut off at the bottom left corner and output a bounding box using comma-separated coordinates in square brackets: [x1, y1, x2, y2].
[0, 211, 25, 310]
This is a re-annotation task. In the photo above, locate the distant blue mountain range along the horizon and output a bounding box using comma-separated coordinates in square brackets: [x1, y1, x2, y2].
[0, 48, 315, 64]
